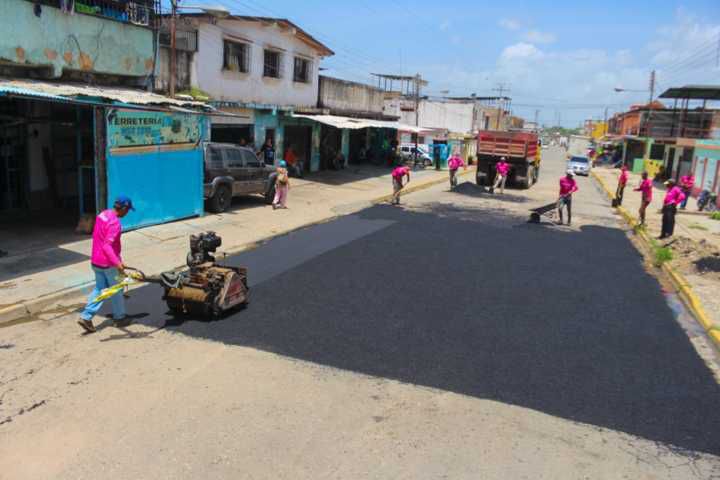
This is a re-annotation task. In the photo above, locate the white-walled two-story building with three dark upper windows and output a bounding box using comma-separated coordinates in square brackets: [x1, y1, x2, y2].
[156, 13, 333, 170]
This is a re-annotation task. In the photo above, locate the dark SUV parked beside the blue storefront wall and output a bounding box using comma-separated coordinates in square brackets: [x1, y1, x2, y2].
[204, 142, 276, 213]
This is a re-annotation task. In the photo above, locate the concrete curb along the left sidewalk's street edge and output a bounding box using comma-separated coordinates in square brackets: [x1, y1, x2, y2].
[0, 168, 475, 328]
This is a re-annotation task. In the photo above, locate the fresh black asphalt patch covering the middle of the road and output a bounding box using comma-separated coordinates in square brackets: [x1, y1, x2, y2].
[109, 198, 720, 454]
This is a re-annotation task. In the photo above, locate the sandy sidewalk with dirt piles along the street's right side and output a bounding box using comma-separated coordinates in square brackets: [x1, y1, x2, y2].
[593, 167, 720, 346]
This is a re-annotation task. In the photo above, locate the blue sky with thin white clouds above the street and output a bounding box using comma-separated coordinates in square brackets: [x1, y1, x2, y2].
[177, 0, 720, 126]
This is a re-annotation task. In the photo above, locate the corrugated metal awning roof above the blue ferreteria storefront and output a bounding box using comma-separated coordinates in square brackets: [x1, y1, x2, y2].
[0, 78, 206, 107]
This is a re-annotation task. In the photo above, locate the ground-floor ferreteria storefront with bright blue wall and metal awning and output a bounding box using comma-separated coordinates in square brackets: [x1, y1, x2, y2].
[0, 81, 209, 236]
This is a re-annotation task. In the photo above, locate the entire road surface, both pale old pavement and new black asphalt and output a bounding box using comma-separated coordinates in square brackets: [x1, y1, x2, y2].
[0, 148, 720, 479]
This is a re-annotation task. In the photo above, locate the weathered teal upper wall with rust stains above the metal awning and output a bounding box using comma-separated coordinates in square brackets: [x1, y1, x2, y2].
[0, 0, 155, 77]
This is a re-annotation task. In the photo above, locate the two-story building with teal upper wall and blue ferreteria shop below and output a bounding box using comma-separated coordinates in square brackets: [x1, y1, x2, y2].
[0, 0, 207, 236]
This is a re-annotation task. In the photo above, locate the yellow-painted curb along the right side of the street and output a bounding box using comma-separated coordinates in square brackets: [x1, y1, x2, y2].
[591, 172, 720, 350]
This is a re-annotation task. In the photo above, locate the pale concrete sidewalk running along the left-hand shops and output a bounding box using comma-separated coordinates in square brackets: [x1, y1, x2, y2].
[0, 166, 474, 326]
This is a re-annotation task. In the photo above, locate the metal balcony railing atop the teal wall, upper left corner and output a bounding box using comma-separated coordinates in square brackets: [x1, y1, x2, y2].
[32, 0, 160, 27]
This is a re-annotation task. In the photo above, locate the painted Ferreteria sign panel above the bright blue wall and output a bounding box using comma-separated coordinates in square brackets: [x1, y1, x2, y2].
[107, 108, 203, 149]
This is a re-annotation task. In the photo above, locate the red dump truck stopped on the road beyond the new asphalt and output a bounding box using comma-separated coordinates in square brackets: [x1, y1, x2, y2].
[475, 130, 542, 188]
